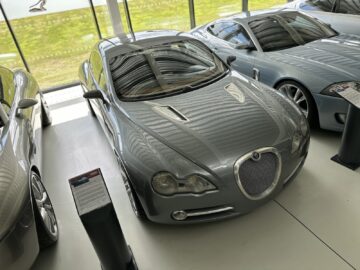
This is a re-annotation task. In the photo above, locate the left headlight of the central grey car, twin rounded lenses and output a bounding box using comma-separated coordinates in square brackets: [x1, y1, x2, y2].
[152, 172, 216, 196]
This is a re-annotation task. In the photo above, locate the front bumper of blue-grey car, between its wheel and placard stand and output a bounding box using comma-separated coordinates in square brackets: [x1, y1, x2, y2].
[313, 94, 349, 132]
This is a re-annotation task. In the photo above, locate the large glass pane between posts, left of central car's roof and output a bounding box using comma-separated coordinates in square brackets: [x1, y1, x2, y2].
[2, 0, 98, 89]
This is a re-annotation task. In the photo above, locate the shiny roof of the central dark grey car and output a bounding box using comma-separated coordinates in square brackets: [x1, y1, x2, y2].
[96, 30, 193, 53]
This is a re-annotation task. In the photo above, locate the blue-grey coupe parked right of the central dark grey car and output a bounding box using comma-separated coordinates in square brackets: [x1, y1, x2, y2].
[191, 11, 360, 131]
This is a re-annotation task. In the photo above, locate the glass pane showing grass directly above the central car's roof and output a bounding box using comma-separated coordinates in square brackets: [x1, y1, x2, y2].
[128, 0, 193, 32]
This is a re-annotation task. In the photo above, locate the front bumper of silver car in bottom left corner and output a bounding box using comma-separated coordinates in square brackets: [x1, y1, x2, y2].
[0, 199, 39, 270]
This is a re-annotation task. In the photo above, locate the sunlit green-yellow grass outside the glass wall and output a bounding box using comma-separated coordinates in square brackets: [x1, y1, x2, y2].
[0, 0, 286, 89]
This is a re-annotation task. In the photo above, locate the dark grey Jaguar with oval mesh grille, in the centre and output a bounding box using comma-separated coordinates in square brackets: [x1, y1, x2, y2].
[80, 31, 309, 224]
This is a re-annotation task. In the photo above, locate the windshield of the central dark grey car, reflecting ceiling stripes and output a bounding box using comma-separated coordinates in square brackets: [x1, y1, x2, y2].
[110, 39, 227, 100]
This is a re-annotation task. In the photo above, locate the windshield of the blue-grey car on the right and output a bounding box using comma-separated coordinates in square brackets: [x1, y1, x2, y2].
[249, 12, 337, 52]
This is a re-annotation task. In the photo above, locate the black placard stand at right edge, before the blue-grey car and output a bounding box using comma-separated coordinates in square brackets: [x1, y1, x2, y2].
[331, 85, 360, 170]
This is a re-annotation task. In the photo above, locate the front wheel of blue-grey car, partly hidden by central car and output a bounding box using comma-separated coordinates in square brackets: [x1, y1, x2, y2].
[275, 81, 319, 128]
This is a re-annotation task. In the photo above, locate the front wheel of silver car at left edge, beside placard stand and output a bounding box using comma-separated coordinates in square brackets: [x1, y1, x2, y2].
[31, 172, 59, 249]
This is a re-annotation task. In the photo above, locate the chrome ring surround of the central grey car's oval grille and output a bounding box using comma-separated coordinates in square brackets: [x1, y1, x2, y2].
[234, 147, 282, 201]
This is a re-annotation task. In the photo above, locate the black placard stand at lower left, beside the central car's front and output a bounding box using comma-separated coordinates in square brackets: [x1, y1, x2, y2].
[69, 169, 138, 270]
